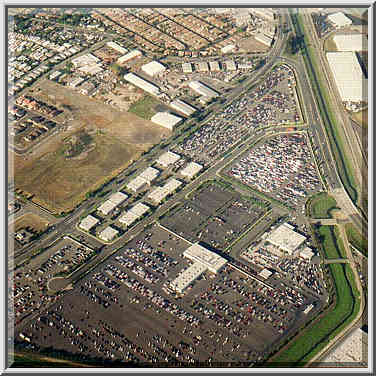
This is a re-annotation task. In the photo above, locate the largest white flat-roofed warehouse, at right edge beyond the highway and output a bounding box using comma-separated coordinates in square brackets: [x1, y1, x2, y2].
[326, 52, 368, 102]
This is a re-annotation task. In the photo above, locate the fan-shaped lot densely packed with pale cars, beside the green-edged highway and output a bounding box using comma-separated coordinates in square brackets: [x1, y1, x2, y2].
[227, 134, 322, 211]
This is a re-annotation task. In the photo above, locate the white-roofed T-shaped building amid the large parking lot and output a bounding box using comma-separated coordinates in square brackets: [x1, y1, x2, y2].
[170, 243, 227, 293]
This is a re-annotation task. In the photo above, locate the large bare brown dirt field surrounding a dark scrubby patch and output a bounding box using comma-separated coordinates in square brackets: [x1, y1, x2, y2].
[8, 81, 170, 212]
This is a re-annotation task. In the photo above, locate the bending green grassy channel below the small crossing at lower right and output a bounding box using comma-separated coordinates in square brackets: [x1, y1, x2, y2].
[266, 264, 360, 367]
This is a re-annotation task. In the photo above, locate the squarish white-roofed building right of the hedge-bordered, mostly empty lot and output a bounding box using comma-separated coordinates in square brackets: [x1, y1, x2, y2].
[266, 223, 306, 256]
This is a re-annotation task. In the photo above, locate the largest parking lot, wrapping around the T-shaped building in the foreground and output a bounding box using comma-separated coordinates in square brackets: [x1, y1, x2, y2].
[17, 225, 326, 366]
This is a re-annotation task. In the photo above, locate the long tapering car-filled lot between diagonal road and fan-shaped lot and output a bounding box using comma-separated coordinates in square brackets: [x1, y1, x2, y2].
[175, 65, 301, 165]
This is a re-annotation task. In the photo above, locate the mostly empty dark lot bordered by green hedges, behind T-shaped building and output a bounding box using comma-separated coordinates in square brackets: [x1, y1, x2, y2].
[160, 183, 268, 250]
